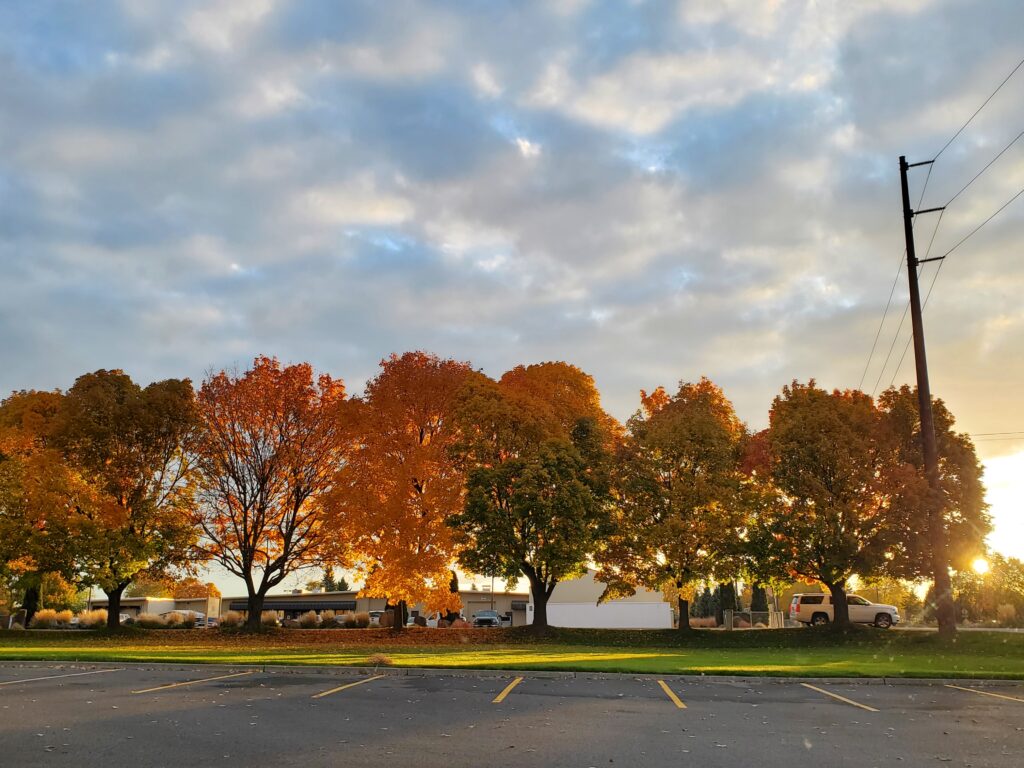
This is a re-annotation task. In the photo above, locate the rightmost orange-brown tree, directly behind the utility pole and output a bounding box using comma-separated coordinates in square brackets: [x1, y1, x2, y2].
[879, 385, 992, 626]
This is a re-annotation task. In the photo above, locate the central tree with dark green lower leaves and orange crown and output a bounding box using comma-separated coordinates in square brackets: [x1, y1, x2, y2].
[450, 362, 618, 631]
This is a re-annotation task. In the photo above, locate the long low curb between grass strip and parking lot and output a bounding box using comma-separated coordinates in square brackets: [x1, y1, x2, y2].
[0, 660, 1024, 687]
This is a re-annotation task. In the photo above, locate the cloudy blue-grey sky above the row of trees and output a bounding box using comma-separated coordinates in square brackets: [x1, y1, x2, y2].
[0, 0, 1024, 593]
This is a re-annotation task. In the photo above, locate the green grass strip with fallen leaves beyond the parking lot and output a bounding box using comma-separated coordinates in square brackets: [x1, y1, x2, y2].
[0, 630, 1024, 679]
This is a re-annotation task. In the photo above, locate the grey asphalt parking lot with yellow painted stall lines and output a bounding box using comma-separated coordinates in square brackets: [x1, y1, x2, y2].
[0, 664, 1024, 768]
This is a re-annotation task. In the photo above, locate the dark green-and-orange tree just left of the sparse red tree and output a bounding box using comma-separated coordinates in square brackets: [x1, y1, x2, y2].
[52, 371, 197, 629]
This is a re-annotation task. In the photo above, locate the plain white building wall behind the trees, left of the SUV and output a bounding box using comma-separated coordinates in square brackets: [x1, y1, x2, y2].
[526, 569, 673, 630]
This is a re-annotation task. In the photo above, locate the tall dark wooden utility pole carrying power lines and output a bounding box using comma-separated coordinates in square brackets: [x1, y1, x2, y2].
[899, 156, 956, 636]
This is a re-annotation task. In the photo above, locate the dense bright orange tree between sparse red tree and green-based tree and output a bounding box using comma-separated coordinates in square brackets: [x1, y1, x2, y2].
[330, 351, 473, 630]
